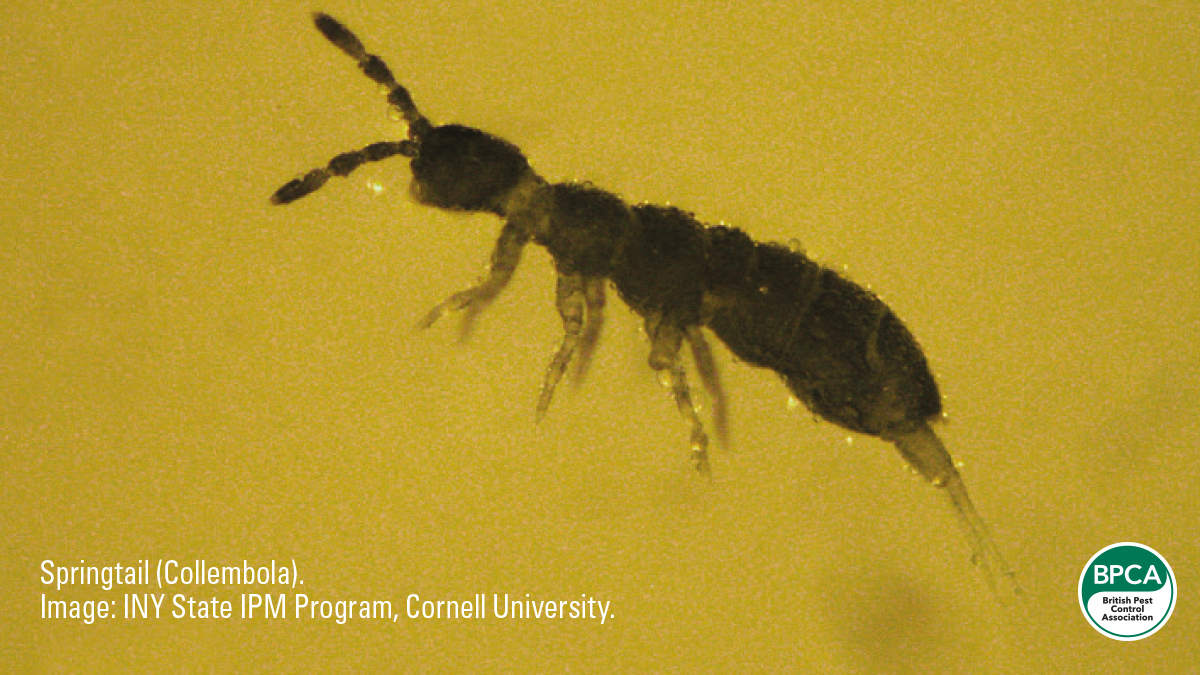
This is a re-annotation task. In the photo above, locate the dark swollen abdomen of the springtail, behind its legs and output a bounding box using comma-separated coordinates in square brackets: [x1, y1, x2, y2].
[708, 233, 942, 438]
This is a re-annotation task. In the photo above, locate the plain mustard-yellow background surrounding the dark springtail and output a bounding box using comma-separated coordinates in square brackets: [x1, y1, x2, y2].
[0, 0, 1200, 673]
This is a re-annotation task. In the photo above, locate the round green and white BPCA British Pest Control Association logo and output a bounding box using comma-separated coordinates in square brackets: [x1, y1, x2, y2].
[1079, 542, 1175, 641]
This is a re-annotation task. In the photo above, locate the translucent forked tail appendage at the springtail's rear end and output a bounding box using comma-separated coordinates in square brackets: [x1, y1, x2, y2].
[889, 423, 1021, 604]
